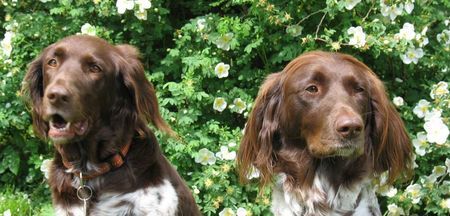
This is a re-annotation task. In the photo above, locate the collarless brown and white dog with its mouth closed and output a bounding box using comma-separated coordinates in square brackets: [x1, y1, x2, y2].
[238, 52, 411, 216]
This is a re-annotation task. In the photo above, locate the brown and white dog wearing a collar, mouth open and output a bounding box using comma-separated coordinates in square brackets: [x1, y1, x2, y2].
[23, 36, 200, 215]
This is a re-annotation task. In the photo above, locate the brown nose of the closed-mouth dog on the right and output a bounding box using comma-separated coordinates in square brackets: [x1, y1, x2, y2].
[335, 114, 363, 138]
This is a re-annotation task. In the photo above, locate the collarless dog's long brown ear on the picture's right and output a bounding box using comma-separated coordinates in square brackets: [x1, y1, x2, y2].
[368, 69, 412, 183]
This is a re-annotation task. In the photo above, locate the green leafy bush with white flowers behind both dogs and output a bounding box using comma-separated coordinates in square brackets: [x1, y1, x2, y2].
[0, 0, 450, 215]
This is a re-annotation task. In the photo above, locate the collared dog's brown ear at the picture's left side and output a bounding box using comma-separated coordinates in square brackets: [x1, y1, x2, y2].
[21, 51, 48, 139]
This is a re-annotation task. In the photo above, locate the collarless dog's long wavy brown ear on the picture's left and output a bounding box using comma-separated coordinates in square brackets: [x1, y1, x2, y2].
[237, 72, 282, 186]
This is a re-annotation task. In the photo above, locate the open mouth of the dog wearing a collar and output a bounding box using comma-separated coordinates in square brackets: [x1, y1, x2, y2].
[48, 114, 88, 140]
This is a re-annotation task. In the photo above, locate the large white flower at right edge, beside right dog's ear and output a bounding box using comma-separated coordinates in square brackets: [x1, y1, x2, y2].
[423, 118, 449, 145]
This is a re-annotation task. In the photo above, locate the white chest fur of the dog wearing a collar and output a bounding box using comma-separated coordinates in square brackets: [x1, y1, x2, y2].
[55, 180, 178, 216]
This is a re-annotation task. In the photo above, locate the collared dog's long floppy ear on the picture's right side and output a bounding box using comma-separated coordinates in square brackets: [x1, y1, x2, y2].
[116, 45, 175, 136]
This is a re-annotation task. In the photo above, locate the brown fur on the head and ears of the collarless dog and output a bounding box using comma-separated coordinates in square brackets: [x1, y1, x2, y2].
[237, 52, 411, 191]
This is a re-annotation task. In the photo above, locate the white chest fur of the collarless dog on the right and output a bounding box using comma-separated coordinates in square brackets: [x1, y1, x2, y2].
[272, 173, 381, 216]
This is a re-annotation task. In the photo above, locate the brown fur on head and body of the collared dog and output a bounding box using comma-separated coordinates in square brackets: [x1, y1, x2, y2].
[23, 36, 200, 215]
